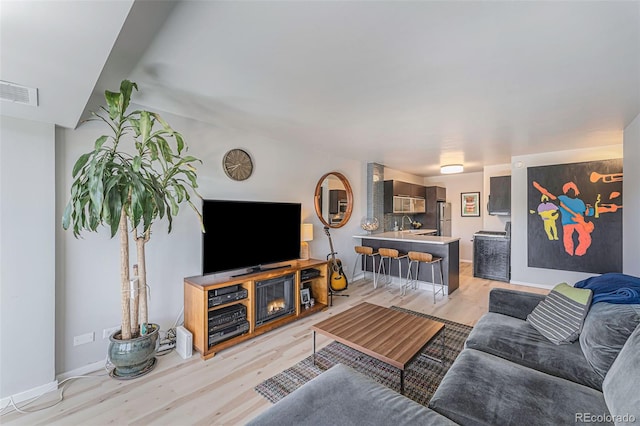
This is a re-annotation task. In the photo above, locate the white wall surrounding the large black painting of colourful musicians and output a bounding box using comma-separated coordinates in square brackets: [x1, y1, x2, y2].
[511, 145, 624, 288]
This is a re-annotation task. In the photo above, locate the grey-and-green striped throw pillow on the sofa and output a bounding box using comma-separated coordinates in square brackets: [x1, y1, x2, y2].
[527, 283, 593, 345]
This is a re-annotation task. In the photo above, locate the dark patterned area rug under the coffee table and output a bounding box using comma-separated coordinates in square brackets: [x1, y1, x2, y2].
[255, 306, 472, 406]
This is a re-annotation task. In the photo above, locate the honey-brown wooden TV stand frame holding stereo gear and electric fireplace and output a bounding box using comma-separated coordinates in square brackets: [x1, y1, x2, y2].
[184, 259, 329, 359]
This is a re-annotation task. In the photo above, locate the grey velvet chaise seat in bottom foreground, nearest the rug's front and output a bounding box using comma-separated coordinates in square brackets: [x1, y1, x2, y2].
[248, 364, 455, 426]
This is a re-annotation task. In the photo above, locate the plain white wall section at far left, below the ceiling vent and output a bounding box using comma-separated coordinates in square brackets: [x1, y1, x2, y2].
[0, 116, 55, 398]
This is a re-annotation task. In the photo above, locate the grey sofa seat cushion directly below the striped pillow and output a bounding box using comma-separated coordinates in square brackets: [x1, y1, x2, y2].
[465, 312, 603, 390]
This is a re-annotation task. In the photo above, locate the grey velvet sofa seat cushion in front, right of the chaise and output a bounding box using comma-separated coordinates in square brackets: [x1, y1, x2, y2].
[429, 349, 610, 425]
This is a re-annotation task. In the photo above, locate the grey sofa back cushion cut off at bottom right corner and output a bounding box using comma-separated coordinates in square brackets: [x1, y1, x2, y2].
[602, 326, 640, 425]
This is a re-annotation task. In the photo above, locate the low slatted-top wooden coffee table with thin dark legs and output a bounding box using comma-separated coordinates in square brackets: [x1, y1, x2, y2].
[311, 302, 444, 393]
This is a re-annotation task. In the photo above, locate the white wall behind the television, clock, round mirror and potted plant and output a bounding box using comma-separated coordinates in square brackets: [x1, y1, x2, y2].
[56, 105, 366, 372]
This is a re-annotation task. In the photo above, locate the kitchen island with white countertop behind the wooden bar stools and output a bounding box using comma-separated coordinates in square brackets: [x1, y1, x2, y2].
[353, 229, 460, 294]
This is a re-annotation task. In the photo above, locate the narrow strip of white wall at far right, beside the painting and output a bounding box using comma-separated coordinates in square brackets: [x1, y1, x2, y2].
[622, 115, 640, 277]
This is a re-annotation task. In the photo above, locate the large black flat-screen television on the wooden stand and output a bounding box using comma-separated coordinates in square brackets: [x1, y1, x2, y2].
[202, 200, 302, 275]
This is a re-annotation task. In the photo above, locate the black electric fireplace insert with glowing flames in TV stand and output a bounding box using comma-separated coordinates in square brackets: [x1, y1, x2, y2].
[255, 274, 296, 326]
